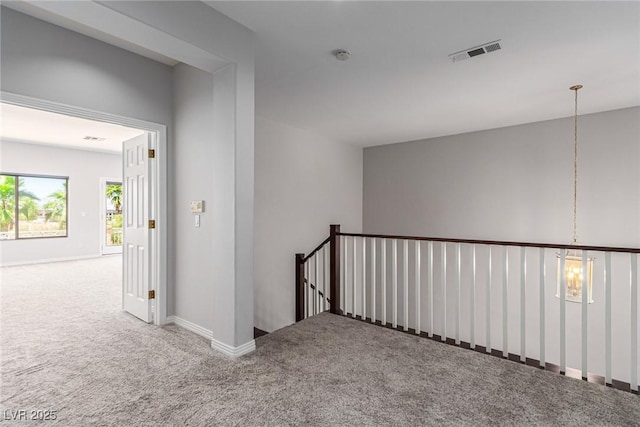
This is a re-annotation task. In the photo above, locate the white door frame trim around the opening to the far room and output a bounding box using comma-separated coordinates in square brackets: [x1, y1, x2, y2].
[0, 91, 167, 325]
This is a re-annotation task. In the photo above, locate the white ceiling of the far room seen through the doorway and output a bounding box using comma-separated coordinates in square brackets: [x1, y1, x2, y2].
[0, 103, 144, 153]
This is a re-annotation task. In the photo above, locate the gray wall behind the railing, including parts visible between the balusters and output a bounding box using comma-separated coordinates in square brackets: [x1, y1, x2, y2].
[360, 107, 640, 381]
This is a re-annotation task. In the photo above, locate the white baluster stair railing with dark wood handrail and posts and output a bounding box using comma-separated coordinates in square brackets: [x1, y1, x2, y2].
[296, 228, 640, 392]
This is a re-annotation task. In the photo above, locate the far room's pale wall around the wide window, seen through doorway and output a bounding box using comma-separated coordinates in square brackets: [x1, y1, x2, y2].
[0, 141, 122, 265]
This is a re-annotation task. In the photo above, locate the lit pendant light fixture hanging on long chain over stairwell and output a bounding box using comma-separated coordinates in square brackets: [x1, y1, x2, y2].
[556, 85, 593, 304]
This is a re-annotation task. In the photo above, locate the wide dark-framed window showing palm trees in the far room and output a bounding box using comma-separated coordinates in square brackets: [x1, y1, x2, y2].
[0, 174, 69, 240]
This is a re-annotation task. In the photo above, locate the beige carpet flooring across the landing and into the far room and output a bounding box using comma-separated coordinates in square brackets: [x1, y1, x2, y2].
[0, 257, 640, 426]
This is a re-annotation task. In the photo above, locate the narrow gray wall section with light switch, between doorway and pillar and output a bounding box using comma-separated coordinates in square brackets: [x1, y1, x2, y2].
[168, 64, 214, 330]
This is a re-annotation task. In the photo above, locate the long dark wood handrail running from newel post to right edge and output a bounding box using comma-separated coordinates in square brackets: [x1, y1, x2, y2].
[338, 233, 640, 254]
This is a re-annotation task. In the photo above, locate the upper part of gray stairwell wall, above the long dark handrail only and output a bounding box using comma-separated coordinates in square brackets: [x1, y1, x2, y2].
[363, 107, 640, 246]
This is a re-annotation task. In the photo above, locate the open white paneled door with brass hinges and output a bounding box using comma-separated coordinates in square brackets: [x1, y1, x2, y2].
[122, 132, 155, 322]
